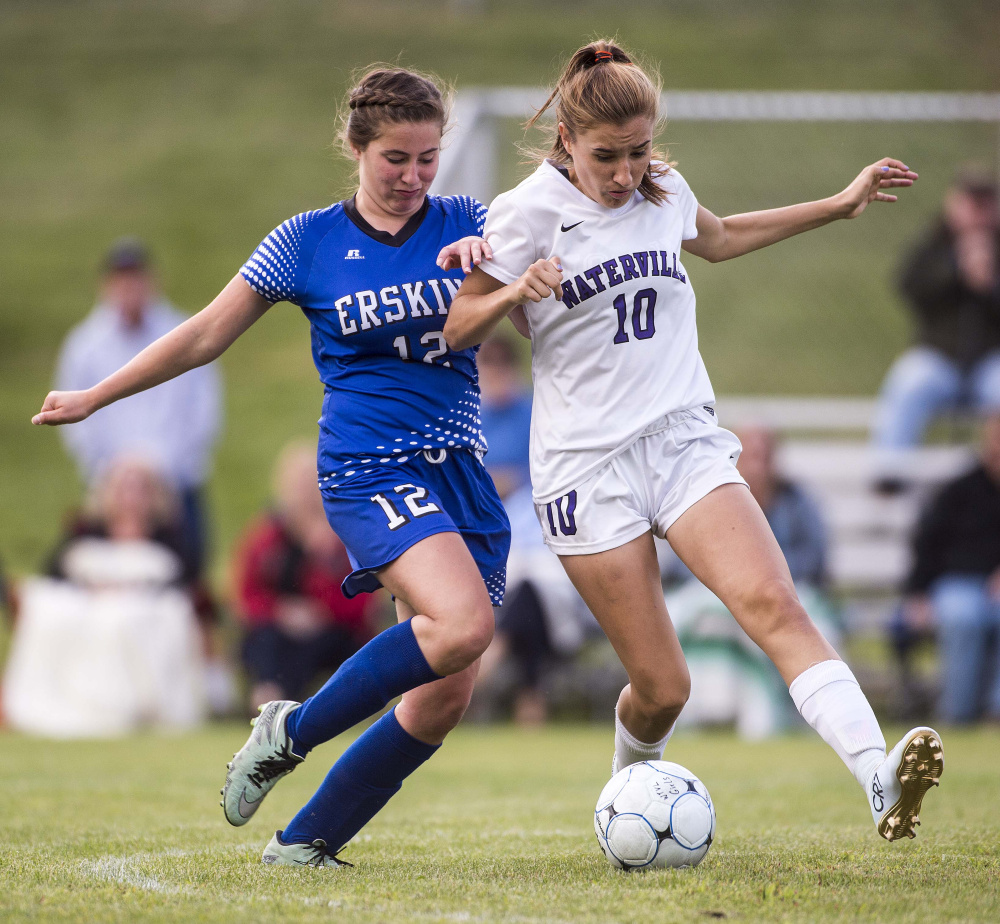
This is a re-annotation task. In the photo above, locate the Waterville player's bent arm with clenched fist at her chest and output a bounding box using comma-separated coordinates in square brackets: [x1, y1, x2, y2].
[444, 257, 562, 350]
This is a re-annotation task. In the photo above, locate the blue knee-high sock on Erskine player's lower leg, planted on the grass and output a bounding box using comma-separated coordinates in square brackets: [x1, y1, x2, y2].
[281, 709, 441, 853]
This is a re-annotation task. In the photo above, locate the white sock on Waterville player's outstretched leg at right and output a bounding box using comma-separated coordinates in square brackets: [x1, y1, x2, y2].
[788, 661, 885, 787]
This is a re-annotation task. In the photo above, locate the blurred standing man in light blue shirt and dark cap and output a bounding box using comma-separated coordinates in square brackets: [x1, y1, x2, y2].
[55, 238, 220, 572]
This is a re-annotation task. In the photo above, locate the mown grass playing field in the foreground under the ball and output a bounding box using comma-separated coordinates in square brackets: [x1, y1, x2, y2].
[0, 725, 1000, 924]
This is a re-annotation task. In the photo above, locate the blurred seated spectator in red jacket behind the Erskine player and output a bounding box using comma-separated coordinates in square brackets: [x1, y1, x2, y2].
[234, 443, 373, 707]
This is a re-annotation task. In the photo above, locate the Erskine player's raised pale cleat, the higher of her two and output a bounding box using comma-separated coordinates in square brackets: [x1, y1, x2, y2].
[219, 699, 304, 825]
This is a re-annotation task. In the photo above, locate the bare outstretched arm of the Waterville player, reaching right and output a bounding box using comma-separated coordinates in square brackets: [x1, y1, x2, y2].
[683, 157, 917, 263]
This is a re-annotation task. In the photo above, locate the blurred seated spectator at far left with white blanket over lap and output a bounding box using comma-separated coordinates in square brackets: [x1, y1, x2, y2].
[4, 457, 211, 737]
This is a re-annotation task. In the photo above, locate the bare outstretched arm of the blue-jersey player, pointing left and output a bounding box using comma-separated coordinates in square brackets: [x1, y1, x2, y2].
[31, 276, 271, 426]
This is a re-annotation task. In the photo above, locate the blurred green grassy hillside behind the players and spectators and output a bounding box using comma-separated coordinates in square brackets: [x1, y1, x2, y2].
[0, 0, 1000, 572]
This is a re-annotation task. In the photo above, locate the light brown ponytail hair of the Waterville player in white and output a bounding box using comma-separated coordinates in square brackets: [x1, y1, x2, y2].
[525, 39, 671, 205]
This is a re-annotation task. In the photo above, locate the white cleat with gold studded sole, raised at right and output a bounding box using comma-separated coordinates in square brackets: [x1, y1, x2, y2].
[868, 727, 944, 841]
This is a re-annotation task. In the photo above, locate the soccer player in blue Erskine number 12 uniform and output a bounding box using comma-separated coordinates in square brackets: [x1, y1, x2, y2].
[32, 68, 509, 867]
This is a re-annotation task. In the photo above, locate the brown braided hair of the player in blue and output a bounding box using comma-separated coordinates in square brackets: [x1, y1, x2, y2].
[338, 65, 451, 154]
